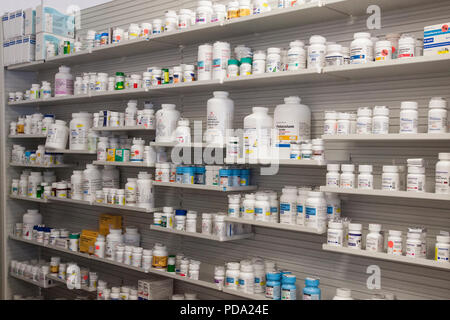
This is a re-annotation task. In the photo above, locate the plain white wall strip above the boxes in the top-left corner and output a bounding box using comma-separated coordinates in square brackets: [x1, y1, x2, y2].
[0, 0, 111, 13]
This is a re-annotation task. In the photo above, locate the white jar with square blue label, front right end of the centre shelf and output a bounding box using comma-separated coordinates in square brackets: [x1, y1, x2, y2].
[305, 191, 327, 232]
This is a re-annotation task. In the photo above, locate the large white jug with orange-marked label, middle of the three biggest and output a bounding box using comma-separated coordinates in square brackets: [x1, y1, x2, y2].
[244, 107, 273, 162]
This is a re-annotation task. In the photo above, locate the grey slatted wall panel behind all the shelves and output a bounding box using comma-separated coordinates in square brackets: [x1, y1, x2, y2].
[2, 0, 450, 299]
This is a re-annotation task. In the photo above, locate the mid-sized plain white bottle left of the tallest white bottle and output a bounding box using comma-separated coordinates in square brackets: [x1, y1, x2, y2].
[155, 104, 180, 142]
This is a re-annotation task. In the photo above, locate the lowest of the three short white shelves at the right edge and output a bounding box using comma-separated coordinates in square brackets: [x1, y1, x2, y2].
[322, 244, 450, 270]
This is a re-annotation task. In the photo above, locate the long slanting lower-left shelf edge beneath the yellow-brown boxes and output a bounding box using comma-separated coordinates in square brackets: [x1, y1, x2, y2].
[9, 235, 219, 290]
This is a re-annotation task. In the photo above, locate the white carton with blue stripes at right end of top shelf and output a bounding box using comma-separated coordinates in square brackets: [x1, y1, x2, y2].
[423, 22, 450, 56]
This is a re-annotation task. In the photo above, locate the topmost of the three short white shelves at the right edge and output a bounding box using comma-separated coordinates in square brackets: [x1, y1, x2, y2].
[322, 133, 450, 142]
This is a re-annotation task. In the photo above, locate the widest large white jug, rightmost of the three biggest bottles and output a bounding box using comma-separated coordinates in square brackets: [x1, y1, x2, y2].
[274, 97, 311, 159]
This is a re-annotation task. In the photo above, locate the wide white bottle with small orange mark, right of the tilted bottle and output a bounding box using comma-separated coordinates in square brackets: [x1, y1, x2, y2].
[69, 112, 92, 150]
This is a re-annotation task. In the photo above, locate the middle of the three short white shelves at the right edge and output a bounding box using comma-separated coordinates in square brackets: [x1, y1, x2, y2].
[320, 186, 450, 201]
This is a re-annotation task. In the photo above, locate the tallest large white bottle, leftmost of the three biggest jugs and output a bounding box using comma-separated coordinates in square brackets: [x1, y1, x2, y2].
[205, 91, 234, 144]
